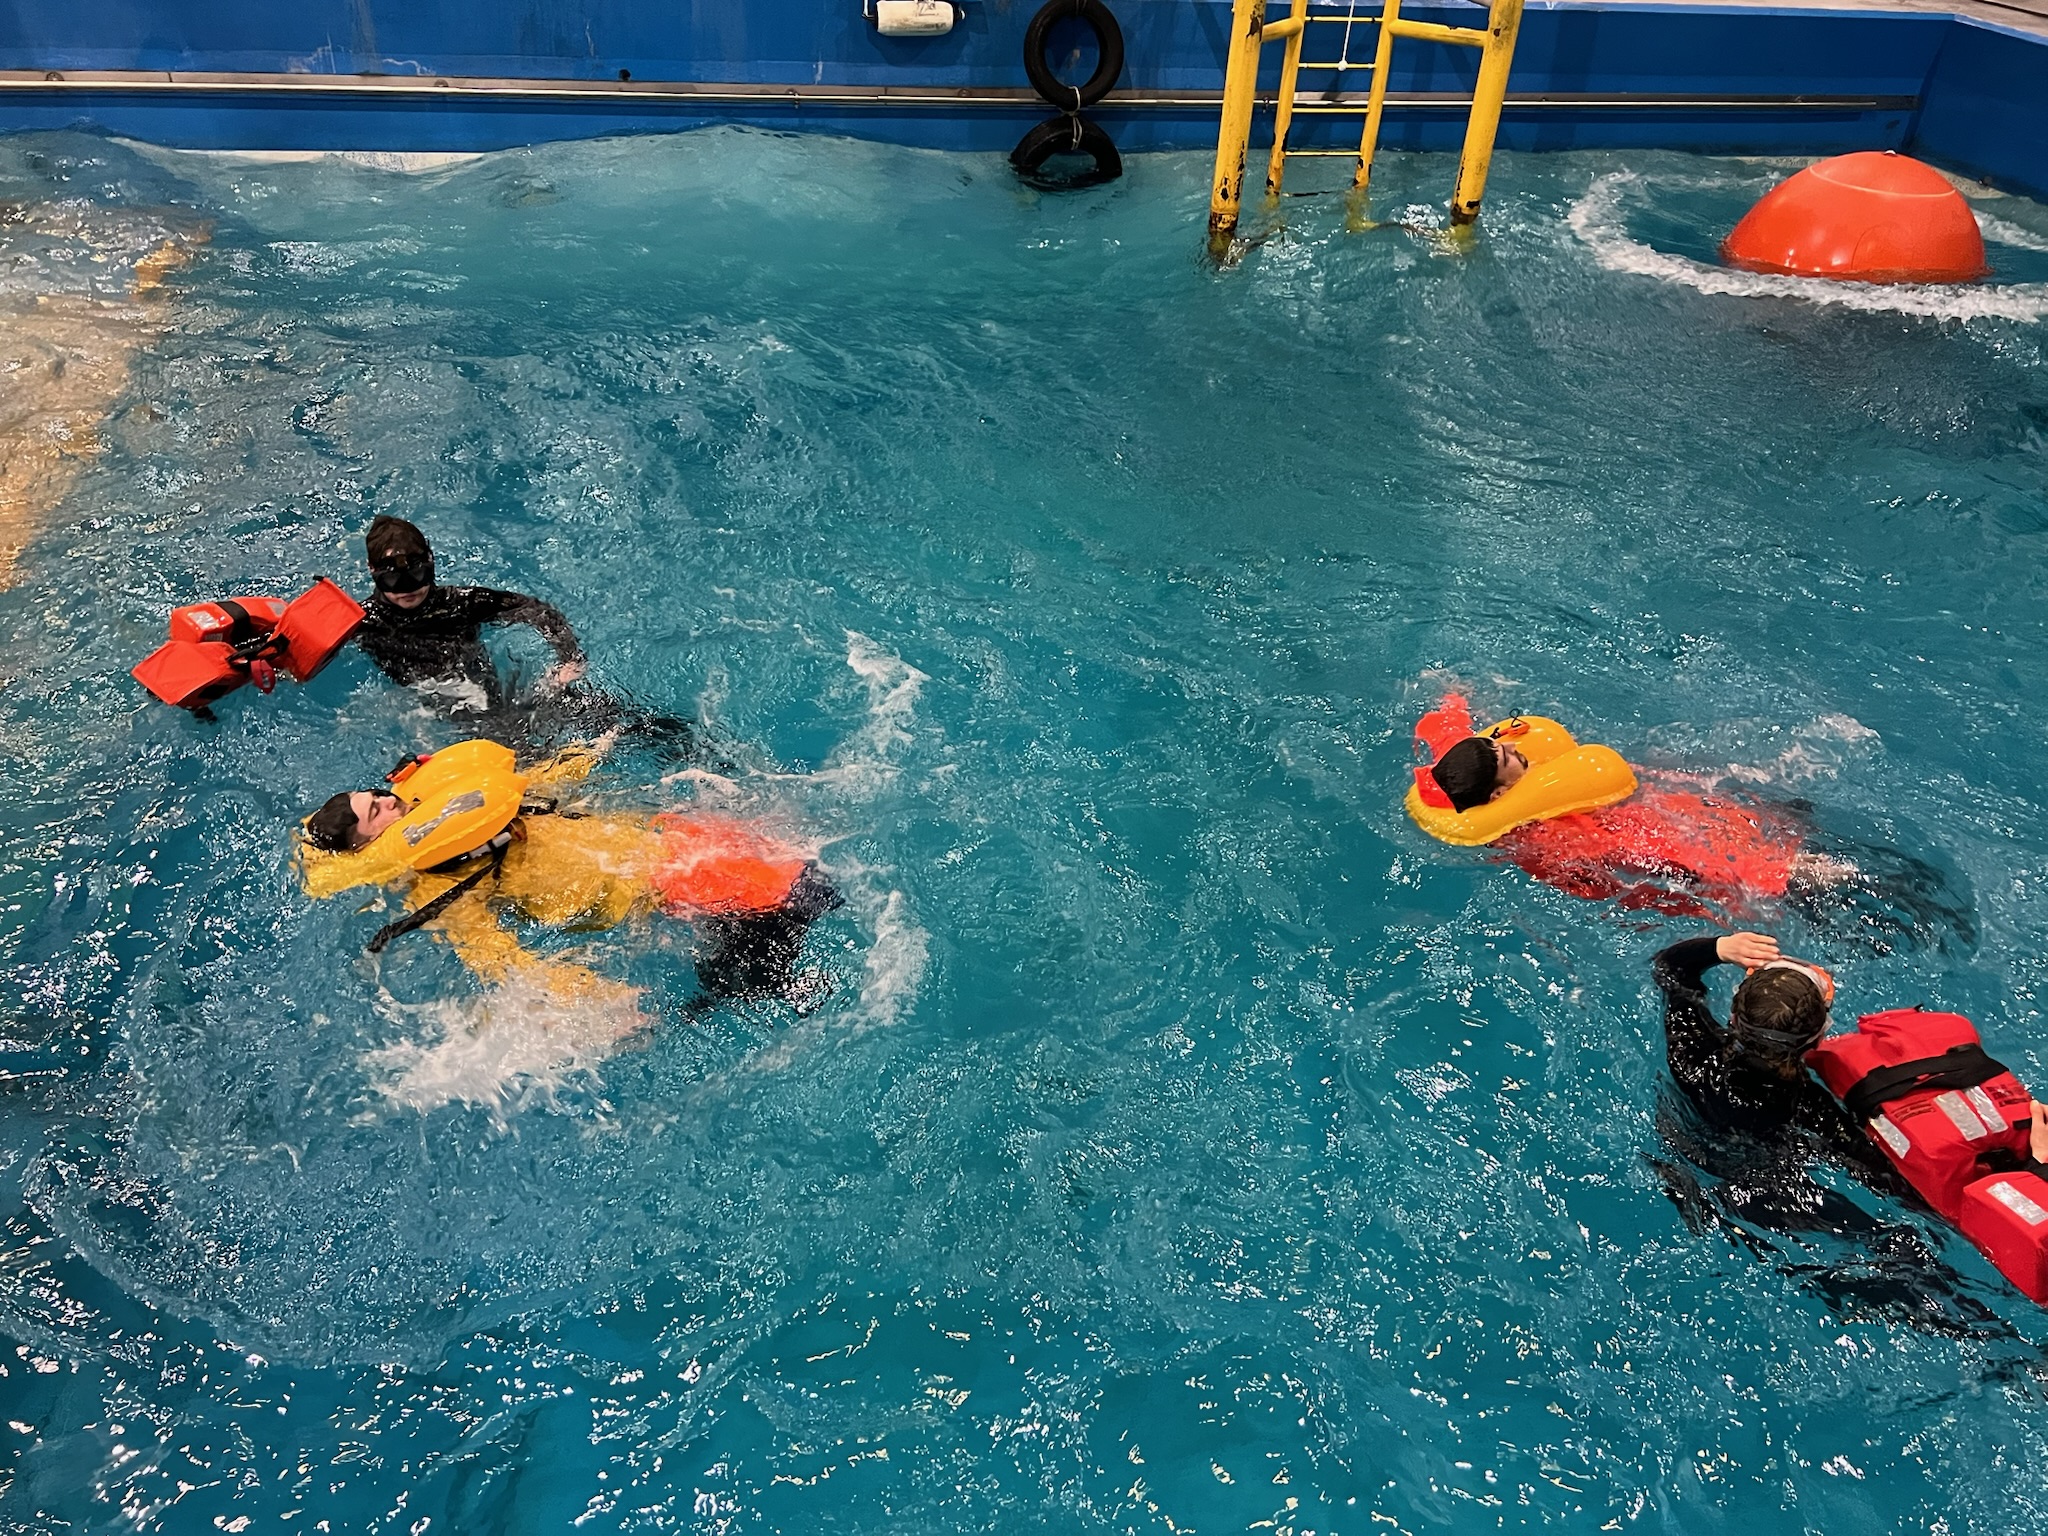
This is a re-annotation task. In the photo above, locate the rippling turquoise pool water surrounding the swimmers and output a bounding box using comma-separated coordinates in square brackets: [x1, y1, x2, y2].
[0, 131, 2048, 1536]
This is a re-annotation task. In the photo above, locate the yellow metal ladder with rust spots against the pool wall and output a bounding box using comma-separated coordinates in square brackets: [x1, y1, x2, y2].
[1208, 0, 1522, 252]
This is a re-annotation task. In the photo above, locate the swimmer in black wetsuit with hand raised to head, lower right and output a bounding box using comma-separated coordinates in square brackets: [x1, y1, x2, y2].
[1649, 932, 2023, 1335]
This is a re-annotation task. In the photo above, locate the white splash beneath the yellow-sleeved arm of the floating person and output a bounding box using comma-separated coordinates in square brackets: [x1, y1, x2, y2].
[365, 975, 649, 1118]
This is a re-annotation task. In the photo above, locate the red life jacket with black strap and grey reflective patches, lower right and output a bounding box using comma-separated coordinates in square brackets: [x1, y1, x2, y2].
[1806, 1008, 2048, 1303]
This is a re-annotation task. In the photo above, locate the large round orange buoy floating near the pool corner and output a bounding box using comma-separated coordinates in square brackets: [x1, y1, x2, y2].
[1720, 150, 1991, 283]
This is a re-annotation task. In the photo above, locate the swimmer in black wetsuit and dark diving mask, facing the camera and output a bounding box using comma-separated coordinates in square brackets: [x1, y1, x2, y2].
[356, 516, 723, 766]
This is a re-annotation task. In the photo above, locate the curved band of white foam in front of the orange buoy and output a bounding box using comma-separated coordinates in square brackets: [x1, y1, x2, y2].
[1567, 172, 2048, 322]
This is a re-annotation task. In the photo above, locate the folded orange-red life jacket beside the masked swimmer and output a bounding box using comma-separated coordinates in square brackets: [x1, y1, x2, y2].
[133, 578, 362, 711]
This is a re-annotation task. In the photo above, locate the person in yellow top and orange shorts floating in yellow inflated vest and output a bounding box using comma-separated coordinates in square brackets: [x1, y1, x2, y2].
[301, 741, 840, 1004]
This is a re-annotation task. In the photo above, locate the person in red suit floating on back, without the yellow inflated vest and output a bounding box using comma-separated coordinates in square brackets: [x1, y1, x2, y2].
[1419, 694, 1976, 952]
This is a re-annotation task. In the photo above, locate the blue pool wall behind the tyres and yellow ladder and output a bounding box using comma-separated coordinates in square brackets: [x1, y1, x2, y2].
[0, 0, 2048, 195]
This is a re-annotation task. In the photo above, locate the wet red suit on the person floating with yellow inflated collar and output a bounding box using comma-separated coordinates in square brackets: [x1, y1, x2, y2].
[1415, 694, 1800, 918]
